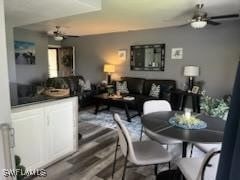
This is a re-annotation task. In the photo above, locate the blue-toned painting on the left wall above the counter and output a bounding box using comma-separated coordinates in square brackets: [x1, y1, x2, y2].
[14, 41, 36, 65]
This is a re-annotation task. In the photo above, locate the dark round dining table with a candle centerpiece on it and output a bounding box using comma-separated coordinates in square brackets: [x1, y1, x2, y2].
[142, 111, 225, 157]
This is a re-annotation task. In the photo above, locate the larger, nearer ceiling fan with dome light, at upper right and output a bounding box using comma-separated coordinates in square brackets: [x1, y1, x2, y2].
[190, 4, 239, 29]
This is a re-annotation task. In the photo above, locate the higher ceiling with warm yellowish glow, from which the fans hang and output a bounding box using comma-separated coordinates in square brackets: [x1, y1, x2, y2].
[6, 0, 240, 35]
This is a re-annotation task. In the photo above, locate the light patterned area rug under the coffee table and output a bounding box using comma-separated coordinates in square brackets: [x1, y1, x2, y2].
[79, 108, 142, 141]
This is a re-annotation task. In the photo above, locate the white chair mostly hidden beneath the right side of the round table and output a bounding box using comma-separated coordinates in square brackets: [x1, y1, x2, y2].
[190, 143, 222, 157]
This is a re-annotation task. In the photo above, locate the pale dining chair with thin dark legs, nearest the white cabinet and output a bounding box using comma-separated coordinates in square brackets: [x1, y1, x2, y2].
[112, 114, 172, 180]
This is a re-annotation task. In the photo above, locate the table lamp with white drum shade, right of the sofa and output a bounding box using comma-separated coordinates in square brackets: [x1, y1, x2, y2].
[184, 66, 199, 91]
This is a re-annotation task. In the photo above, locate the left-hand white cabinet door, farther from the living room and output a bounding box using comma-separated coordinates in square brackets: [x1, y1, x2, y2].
[12, 109, 45, 169]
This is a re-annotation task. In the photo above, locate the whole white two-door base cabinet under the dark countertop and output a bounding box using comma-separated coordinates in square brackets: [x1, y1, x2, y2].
[12, 98, 78, 169]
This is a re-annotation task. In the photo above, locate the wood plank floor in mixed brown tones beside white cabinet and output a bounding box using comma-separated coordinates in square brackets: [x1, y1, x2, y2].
[35, 122, 158, 180]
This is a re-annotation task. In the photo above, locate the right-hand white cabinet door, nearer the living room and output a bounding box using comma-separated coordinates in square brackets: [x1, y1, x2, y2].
[46, 102, 74, 161]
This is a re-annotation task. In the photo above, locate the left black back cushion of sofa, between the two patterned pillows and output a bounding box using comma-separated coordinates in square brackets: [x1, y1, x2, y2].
[122, 77, 145, 94]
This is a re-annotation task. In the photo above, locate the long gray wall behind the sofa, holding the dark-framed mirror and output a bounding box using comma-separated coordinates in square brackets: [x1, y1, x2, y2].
[62, 21, 240, 96]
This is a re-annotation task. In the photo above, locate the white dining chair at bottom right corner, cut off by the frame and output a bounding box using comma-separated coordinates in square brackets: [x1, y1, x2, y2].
[176, 148, 220, 180]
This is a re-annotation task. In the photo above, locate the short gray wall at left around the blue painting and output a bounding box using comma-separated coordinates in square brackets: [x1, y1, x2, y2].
[14, 28, 48, 84]
